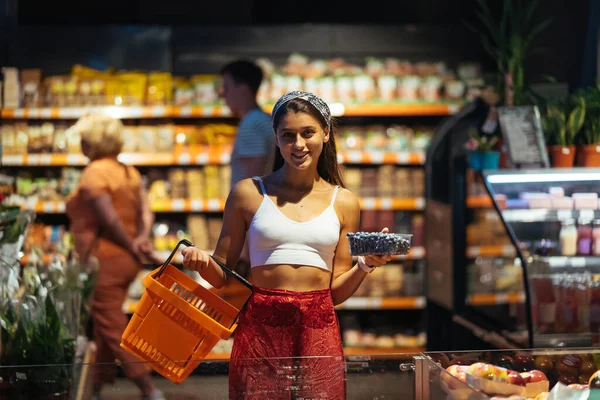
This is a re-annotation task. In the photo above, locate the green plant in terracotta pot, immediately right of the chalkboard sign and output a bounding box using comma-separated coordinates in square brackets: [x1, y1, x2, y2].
[542, 96, 585, 168]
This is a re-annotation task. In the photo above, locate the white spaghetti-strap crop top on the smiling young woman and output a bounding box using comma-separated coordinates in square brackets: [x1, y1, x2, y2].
[248, 176, 340, 271]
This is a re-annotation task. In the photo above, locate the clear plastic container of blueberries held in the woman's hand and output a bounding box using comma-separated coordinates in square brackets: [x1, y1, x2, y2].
[348, 232, 413, 256]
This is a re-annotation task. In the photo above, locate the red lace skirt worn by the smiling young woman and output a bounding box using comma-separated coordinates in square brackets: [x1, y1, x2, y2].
[229, 287, 346, 400]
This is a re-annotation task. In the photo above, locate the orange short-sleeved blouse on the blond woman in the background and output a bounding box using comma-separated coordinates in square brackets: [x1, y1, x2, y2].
[66, 158, 142, 259]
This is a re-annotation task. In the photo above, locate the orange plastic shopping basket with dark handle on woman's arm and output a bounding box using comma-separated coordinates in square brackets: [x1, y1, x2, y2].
[121, 240, 252, 383]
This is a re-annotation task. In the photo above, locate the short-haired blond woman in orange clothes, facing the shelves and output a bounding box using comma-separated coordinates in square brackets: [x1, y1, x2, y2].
[66, 115, 164, 400]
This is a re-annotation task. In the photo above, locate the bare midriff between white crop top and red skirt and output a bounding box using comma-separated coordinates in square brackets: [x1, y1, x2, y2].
[251, 265, 331, 292]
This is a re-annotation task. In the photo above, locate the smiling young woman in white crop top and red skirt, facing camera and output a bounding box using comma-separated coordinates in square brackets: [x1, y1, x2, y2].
[183, 91, 390, 400]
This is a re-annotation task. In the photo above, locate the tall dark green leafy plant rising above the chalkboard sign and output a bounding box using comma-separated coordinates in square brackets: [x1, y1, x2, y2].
[467, 0, 552, 105]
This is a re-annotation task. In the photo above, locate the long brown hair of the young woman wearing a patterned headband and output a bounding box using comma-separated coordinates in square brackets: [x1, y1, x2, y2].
[273, 98, 345, 187]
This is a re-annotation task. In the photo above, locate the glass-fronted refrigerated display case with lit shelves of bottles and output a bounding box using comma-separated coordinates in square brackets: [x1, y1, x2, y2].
[482, 168, 600, 348]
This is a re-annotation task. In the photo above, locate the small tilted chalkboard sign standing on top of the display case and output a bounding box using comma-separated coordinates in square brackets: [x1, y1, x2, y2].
[498, 106, 550, 168]
